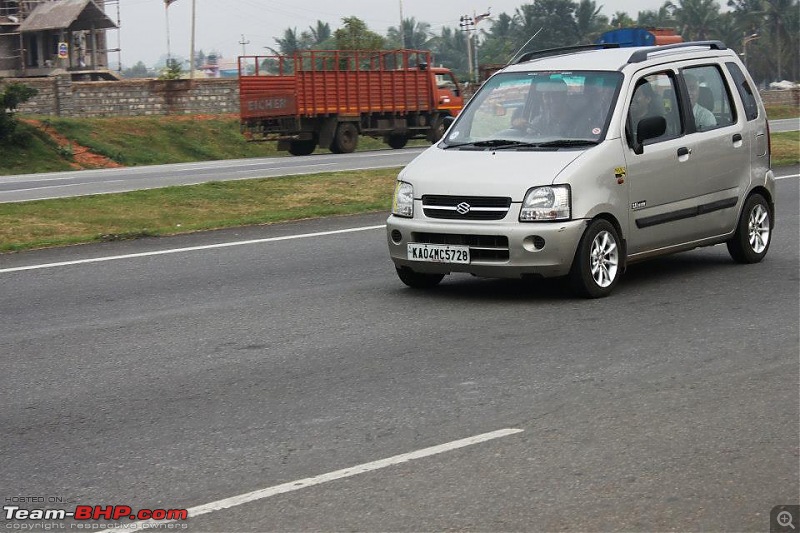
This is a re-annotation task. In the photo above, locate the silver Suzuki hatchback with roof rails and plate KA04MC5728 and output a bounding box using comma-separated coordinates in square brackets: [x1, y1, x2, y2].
[387, 41, 775, 297]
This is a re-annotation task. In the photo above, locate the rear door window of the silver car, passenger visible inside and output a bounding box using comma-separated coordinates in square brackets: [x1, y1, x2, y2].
[682, 65, 736, 131]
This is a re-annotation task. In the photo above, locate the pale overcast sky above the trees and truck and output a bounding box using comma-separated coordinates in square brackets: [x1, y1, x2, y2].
[114, 0, 664, 67]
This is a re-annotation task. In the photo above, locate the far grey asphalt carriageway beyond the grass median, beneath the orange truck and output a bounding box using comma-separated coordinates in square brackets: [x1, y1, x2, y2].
[0, 119, 800, 203]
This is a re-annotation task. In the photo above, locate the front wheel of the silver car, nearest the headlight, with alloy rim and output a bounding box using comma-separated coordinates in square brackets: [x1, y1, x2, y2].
[569, 219, 623, 298]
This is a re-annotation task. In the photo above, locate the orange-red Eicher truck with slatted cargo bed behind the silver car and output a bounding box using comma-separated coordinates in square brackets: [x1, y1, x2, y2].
[239, 50, 464, 155]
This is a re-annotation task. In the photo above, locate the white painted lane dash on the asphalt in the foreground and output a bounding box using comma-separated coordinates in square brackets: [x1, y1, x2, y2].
[106, 428, 525, 532]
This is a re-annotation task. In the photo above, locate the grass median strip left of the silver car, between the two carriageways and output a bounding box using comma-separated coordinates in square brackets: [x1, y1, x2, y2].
[0, 168, 399, 252]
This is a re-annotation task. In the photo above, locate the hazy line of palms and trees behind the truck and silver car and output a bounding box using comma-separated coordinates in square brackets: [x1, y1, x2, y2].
[271, 0, 800, 83]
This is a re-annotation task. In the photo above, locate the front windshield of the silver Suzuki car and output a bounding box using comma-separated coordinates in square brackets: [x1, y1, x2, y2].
[444, 71, 622, 149]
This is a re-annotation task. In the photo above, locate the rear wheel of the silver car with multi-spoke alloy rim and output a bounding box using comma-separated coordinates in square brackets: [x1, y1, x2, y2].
[726, 193, 772, 264]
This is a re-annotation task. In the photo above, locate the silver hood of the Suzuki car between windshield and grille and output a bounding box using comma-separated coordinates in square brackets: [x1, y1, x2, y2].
[398, 146, 586, 202]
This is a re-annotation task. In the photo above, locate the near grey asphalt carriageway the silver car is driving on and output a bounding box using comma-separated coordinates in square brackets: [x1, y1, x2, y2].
[0, 169, 800, 532]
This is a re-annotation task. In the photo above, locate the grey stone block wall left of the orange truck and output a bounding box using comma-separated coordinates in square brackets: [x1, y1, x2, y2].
[0, 76, 239, 117]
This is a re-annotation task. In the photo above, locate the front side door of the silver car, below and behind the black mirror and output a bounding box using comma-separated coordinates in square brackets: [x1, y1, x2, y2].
[624, 69, 697, 256]
